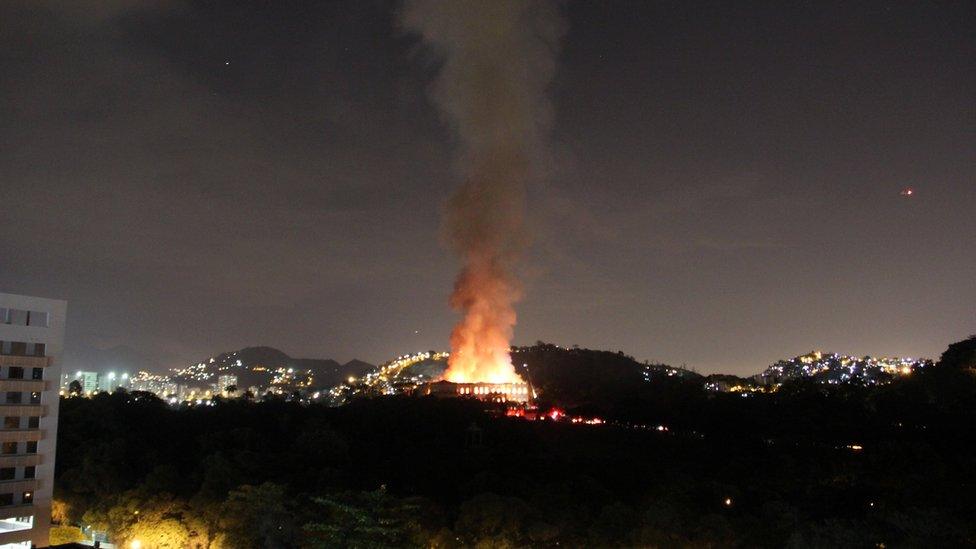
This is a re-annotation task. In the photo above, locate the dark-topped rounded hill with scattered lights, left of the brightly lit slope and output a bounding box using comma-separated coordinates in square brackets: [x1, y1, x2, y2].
[173, 346, 373, 390]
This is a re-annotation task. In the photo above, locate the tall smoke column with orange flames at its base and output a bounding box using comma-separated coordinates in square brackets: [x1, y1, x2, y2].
[401, 0, 565, 383]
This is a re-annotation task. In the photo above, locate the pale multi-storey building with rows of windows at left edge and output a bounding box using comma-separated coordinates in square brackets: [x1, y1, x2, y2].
[0, 293, 67, 549]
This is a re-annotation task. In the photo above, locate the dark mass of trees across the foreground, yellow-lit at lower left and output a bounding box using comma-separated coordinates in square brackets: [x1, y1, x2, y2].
[55, 339, 976, 548]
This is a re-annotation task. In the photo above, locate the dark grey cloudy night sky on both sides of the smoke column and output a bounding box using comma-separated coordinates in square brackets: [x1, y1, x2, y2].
[0, 0, 976, 374]
